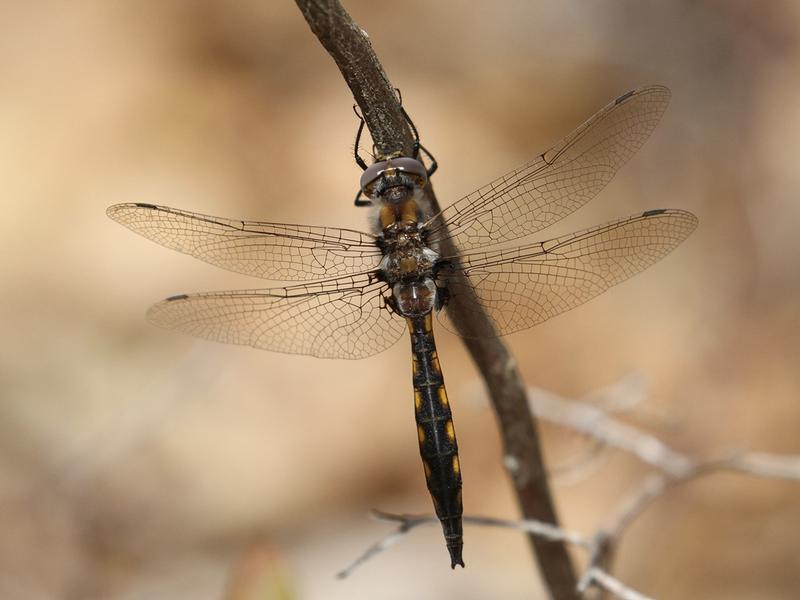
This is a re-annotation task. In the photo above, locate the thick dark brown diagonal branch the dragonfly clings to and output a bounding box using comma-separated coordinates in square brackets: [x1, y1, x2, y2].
[296, 0, 577, 600]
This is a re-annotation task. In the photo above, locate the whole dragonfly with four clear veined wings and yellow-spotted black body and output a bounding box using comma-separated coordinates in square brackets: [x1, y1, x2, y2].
[107, 85, 698, 568]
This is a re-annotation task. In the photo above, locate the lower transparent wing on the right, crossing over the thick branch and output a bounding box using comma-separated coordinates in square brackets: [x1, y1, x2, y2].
[439, 209, 697, 337]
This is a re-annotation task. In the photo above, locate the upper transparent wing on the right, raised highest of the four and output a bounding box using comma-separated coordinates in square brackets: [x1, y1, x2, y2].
[427, 86, 670, 250]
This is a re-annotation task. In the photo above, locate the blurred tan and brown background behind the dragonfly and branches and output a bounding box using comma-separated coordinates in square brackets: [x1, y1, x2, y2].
[0, 0, 800, 600]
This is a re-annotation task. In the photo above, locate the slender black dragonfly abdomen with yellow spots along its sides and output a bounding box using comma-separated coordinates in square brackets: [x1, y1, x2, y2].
[407, 313, 464, 568]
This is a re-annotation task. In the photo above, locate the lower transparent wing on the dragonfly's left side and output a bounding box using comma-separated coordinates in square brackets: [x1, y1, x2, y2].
[147, 273, 405, 358]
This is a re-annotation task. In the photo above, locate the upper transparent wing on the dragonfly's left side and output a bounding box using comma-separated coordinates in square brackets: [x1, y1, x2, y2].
[107, 204, 381, 280]
